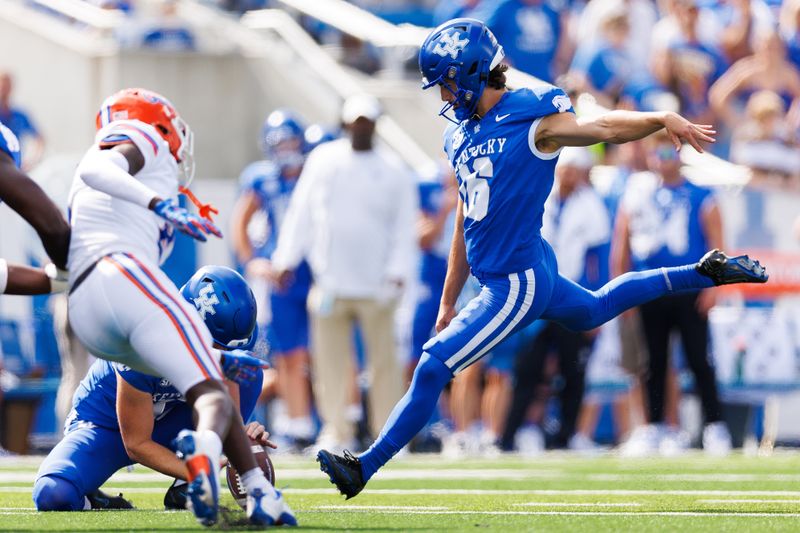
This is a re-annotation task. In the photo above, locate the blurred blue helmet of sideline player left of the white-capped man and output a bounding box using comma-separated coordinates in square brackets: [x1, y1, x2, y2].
[261, 109, 306, 172]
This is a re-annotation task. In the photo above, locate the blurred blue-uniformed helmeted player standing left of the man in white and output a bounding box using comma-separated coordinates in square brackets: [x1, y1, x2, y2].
[231, 109, 315, 449]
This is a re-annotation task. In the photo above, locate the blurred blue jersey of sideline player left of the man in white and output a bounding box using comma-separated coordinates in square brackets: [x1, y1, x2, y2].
[239, 161, 311, 296]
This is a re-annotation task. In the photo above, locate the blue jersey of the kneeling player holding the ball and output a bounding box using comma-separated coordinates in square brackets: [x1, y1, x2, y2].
[66, 359, 262, 429]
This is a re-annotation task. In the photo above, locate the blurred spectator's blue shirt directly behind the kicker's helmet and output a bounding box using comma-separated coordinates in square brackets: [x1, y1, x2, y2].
[469, 0, 569, 82]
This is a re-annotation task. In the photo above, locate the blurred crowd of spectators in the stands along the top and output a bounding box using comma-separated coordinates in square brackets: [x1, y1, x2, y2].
[51, 0, 800, 190]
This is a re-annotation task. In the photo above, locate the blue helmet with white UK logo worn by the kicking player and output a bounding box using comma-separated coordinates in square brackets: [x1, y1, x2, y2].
[419, 18, 505, 123]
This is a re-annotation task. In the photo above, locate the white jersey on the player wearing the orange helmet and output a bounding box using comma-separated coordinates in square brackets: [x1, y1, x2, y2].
[69, 120, 179, 279]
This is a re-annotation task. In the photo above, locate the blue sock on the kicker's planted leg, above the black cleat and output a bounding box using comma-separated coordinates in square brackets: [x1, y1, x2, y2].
[359, 352, 453, 483]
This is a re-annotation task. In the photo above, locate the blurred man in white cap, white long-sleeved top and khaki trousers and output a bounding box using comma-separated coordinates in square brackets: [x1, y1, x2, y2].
[273, 94, 418, 450]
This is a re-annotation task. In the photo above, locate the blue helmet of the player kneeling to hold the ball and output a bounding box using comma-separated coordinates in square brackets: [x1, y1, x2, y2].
[181, 266, 258, 350]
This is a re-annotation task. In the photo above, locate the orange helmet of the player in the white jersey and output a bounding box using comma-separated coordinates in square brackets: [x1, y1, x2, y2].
[95, 88, 194, 186]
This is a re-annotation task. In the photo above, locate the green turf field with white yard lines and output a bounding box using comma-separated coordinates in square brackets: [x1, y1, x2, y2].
[0, 452, 800, 533]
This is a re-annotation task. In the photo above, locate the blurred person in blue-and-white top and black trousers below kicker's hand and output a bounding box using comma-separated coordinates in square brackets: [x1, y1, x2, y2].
[612, 128, 731, 454]
